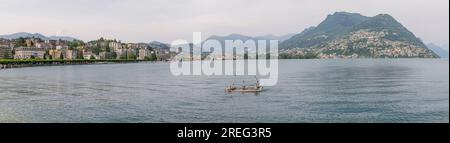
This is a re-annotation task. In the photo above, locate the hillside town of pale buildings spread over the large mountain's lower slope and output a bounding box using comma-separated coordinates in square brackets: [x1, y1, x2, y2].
[280, 29, 437, 59]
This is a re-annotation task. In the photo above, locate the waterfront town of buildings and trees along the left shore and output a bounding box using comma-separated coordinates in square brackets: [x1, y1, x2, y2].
[0, 37, 174, 61]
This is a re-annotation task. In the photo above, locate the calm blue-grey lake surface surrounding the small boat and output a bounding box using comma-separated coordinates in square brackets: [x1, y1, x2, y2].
[0, 59, 449, 123]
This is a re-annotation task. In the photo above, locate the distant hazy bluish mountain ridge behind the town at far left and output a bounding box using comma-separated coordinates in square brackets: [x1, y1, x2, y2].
[0, 32, 77, 41]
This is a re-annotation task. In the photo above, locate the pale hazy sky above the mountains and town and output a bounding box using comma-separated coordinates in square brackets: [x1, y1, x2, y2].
[0, 0, 449, 45]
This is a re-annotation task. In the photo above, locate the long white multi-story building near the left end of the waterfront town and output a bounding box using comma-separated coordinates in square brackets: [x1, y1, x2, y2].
[14, 47, 45, 59]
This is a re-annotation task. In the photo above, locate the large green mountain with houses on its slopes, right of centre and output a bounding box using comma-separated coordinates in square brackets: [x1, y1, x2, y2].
[280, 12, 437, 58]
